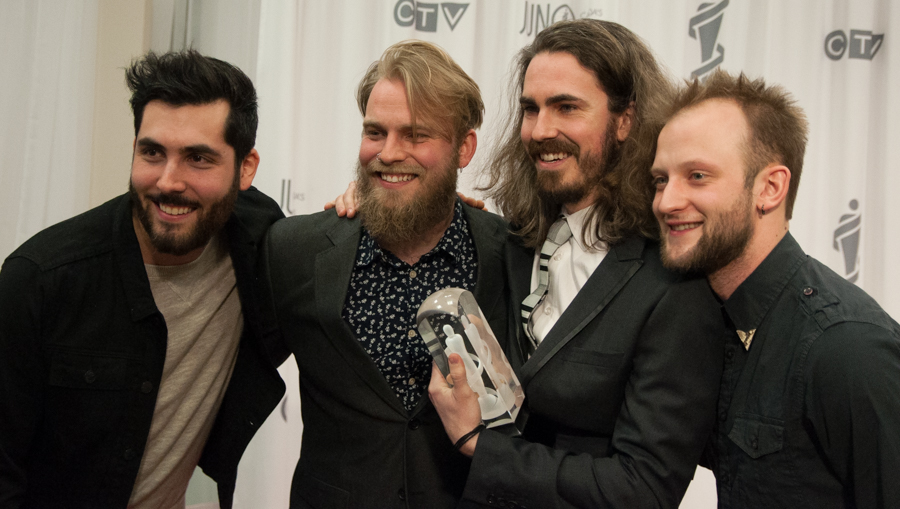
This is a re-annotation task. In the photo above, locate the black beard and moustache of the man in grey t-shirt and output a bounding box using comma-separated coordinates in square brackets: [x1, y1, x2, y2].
[128, 172, 240, 256]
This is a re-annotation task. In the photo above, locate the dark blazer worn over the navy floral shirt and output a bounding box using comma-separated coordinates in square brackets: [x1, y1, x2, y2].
[262, 207, 509, 509]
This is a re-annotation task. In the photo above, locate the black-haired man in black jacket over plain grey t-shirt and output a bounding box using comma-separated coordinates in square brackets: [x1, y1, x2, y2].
[0, 51, 284, 508]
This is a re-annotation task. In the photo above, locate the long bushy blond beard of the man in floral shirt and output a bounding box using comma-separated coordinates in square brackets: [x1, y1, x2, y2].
[356, 155, 459, 246]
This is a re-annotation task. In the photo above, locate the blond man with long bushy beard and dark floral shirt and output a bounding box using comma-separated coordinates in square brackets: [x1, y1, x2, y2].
[263, 41, 508, 508]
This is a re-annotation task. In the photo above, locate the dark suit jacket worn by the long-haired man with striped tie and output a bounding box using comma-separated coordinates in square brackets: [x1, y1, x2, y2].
[463, 238, 723, 509]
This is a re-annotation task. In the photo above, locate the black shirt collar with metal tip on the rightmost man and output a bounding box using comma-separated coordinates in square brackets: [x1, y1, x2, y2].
[723, 233, 806, 338]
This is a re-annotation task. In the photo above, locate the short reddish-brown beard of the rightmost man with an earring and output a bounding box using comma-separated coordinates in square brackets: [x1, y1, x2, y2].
[660, 193, 753, 275]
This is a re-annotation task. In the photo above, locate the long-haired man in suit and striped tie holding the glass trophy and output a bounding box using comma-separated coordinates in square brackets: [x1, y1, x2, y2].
[429, 19, 722, 508]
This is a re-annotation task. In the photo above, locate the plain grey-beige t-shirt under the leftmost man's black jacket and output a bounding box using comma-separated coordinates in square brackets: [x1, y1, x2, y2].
[128, 235, 244, 508]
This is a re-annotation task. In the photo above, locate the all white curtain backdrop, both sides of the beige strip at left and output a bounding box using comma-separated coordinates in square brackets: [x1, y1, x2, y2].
[0, 0, 900, 508]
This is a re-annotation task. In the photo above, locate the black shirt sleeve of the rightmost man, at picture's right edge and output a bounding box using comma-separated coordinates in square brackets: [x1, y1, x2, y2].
[805, 322, 900, 508]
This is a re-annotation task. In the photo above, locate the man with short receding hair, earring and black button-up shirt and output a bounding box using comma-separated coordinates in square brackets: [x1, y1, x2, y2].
[652, 71, 900, 508]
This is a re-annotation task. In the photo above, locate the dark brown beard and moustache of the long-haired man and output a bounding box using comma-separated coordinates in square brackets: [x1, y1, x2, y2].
[527, 118, 621, 205]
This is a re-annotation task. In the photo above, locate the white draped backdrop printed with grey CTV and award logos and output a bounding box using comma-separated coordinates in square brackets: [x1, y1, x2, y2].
[223, 0, 900, 507]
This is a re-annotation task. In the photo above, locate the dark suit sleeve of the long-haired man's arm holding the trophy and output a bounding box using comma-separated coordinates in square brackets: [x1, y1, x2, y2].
[464, 280, 723, 509]
